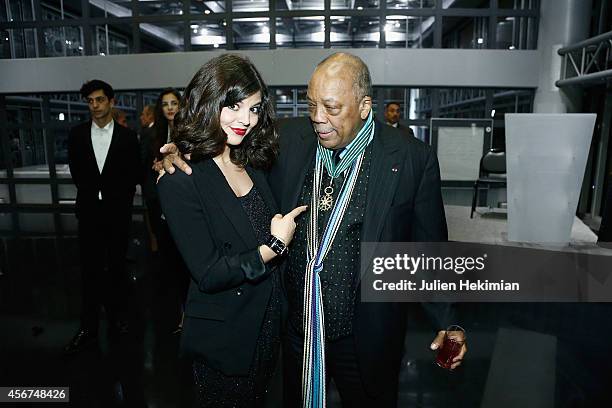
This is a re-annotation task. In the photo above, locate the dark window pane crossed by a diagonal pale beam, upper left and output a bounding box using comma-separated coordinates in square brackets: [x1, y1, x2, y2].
[138, 21, 185, 53]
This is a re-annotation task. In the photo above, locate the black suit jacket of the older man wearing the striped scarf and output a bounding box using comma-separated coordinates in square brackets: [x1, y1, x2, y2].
[269, 118, 447, 394]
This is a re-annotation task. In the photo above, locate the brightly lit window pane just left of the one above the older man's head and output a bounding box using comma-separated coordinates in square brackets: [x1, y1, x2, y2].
[276, 16, 325, 48]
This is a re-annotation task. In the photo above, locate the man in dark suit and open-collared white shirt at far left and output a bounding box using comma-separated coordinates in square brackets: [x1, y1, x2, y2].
[65, 80, 141, 353]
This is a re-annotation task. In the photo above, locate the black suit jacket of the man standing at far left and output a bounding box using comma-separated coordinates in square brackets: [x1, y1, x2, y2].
[68, 121, 142, 220]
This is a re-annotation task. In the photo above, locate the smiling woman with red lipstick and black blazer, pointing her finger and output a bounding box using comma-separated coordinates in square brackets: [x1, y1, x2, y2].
[158, 54, 306, 407]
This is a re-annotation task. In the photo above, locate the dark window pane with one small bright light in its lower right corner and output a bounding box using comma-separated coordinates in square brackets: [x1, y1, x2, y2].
[442, 17, 489, 49]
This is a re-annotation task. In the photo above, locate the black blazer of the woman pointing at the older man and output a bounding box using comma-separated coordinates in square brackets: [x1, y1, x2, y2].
[158, 159, 277, 375]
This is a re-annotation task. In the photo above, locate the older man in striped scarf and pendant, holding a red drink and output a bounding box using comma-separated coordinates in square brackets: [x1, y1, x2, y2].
[164, 53, 466, 407]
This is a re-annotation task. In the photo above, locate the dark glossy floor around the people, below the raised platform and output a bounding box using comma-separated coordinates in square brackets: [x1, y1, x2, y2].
[0, 220, 612, 408]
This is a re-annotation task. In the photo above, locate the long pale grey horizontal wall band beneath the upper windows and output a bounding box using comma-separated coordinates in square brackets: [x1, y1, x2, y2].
[0, 49, 539, 93]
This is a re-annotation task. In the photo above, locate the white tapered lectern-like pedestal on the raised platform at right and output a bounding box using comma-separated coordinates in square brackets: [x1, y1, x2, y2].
[506, 113, 596, 245]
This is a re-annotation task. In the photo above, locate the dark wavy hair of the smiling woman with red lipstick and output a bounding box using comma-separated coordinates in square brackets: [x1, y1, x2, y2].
[173, 54, 278, 169]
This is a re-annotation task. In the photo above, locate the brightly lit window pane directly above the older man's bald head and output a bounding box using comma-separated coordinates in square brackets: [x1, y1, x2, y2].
[330, 16, 380, 48]
